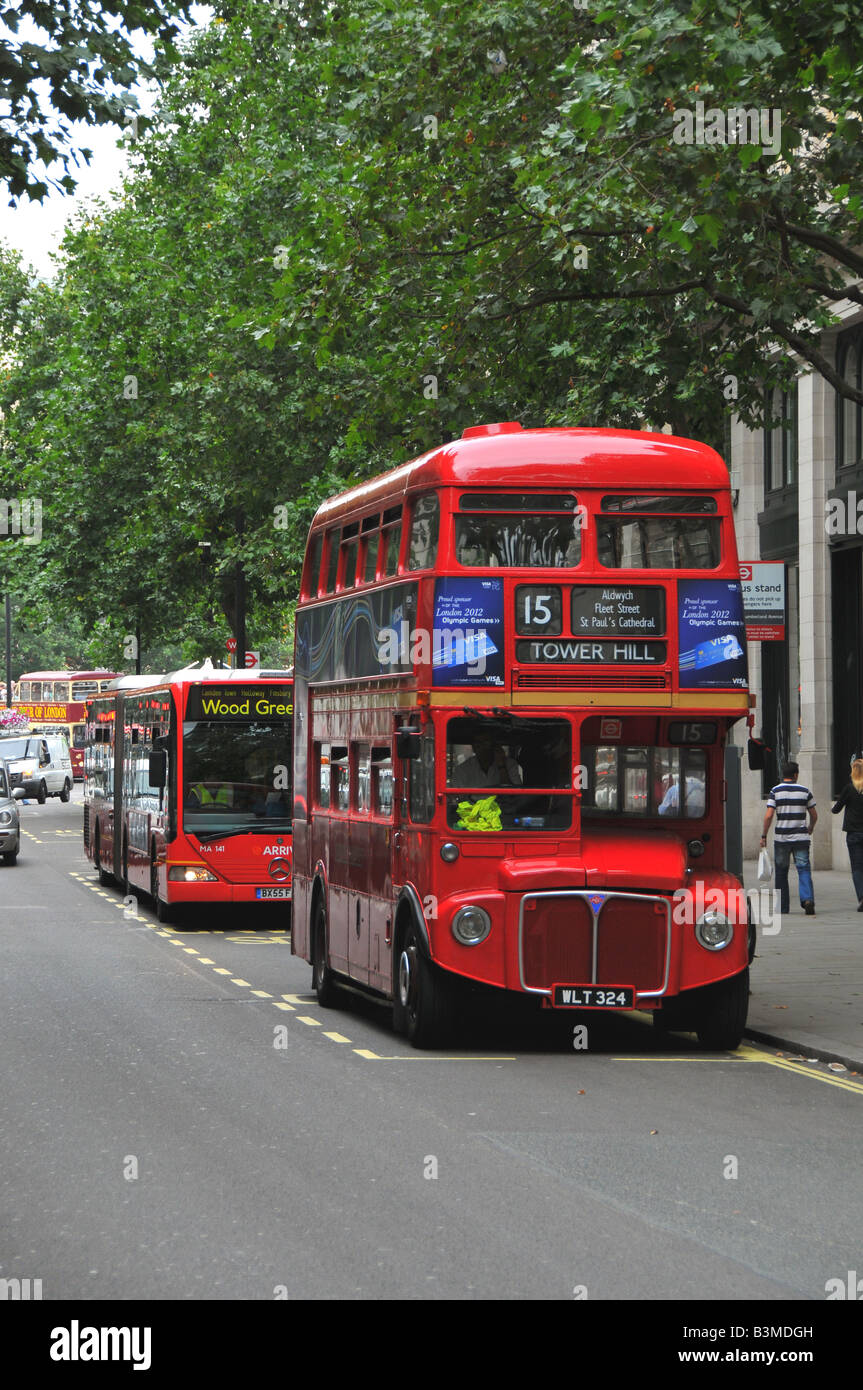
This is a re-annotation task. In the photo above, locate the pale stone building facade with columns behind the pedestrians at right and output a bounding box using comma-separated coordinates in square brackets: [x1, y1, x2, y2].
[728, 290, 863, 867]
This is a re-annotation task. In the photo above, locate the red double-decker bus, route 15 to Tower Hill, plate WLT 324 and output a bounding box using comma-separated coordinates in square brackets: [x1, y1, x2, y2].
[292, 424, 749, 1048]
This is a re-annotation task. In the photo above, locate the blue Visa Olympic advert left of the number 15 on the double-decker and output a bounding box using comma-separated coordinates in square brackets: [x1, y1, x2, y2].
[432, 577, 504, 685]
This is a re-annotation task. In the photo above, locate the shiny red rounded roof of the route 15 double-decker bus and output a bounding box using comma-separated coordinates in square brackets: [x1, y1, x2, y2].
[313, 421, 730, 527]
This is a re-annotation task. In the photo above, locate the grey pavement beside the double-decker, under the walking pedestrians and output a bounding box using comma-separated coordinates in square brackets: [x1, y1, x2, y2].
[743, 859, 863, 1073]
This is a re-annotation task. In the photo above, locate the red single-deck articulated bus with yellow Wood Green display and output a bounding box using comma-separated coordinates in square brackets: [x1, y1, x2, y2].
[83, 663, 293, 922]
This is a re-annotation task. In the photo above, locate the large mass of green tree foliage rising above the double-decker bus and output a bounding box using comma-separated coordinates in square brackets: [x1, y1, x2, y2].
[0, 0, 863, 660]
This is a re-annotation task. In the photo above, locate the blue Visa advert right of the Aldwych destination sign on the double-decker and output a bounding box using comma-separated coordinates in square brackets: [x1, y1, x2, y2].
[677, 580, 748, 689]
